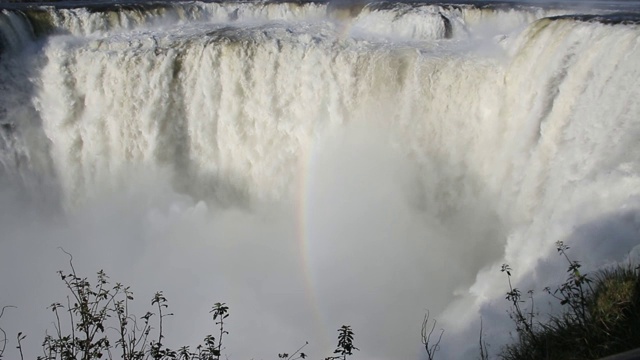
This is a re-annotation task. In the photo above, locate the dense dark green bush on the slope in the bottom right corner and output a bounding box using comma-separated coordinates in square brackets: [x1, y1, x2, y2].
[499, 242, 640, 360]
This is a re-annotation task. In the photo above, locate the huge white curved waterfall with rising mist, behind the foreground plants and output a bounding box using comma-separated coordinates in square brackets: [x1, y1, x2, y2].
[0, 2, 640, 359]
